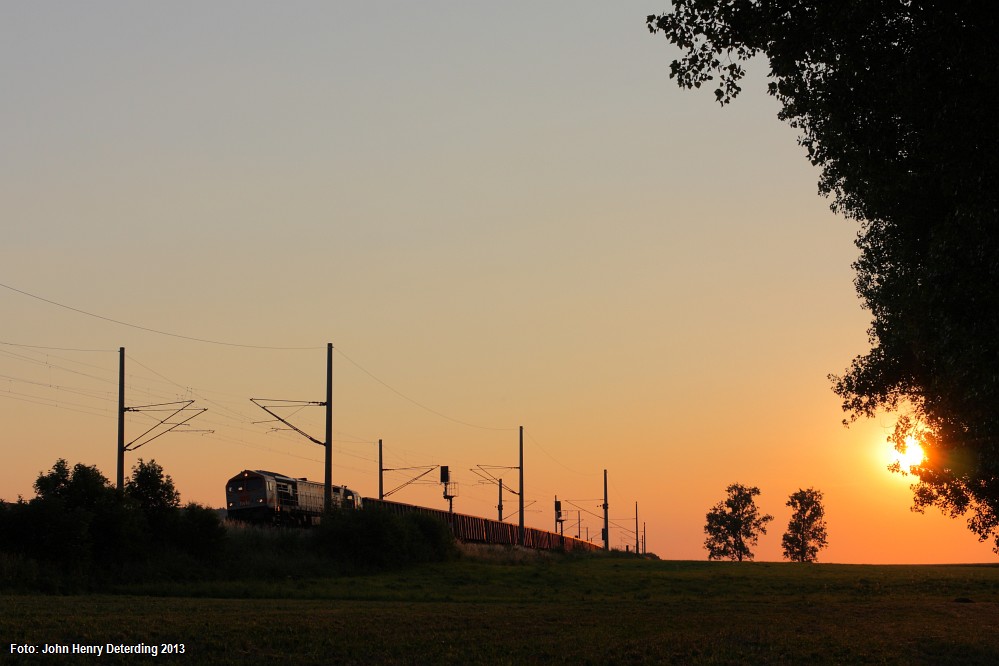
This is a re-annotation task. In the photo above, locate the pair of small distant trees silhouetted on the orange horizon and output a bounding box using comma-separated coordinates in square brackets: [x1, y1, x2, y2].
[704, 483, 828, 562]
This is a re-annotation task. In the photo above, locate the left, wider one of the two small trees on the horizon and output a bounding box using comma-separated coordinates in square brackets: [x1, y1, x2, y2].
[704, 483, 774, 562]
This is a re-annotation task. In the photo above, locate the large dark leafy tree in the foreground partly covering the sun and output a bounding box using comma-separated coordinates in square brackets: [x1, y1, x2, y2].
[647, 0, 999, 552]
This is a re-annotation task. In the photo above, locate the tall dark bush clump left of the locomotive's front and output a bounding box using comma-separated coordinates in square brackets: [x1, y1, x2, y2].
[0, 459, 226, 591]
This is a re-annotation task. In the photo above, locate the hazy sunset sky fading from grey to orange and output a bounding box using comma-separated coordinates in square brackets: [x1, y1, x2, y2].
[0, 0, 996, 563]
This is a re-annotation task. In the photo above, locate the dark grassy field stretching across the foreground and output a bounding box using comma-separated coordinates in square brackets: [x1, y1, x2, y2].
[0, 556, 999, 665]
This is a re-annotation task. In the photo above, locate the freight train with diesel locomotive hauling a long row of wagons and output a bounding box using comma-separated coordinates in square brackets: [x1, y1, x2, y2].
[225, 470, 600, 551]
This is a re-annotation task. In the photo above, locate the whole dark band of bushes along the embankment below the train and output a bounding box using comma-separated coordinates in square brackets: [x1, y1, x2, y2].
[0, 460, 457, 593]
